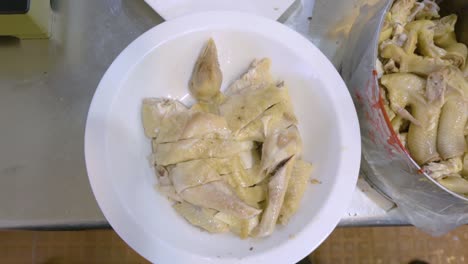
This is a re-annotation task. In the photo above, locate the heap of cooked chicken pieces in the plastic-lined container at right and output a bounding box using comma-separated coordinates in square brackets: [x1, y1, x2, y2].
[376, 0, 468, 196]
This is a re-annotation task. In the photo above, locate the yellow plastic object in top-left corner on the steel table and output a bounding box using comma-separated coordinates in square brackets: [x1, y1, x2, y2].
[0, 0, 51, 39]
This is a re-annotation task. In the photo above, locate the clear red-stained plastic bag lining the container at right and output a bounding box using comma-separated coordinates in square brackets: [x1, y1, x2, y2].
[340, 1, 468, 235]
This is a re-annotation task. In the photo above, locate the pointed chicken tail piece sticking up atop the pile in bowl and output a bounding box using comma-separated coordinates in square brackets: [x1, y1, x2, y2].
[189, 39, 223, 102]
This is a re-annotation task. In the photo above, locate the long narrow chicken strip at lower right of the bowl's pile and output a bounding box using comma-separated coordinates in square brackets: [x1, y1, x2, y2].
[253, 156, 296, 237]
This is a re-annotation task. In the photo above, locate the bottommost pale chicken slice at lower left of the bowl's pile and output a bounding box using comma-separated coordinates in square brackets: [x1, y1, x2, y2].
[173, 202, 229, 233]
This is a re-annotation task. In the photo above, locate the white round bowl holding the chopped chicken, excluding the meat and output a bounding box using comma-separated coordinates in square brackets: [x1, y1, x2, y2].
[85, 12, 361, 263]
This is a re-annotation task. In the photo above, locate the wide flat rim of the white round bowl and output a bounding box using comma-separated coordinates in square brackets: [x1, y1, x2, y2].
[85, 12, 361, 263]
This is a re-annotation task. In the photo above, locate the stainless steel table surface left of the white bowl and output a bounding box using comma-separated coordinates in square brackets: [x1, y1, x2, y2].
[0, 0, 162, 227]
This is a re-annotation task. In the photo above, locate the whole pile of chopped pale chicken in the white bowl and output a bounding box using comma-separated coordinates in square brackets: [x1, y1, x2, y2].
[142, 39, 311, 239]
